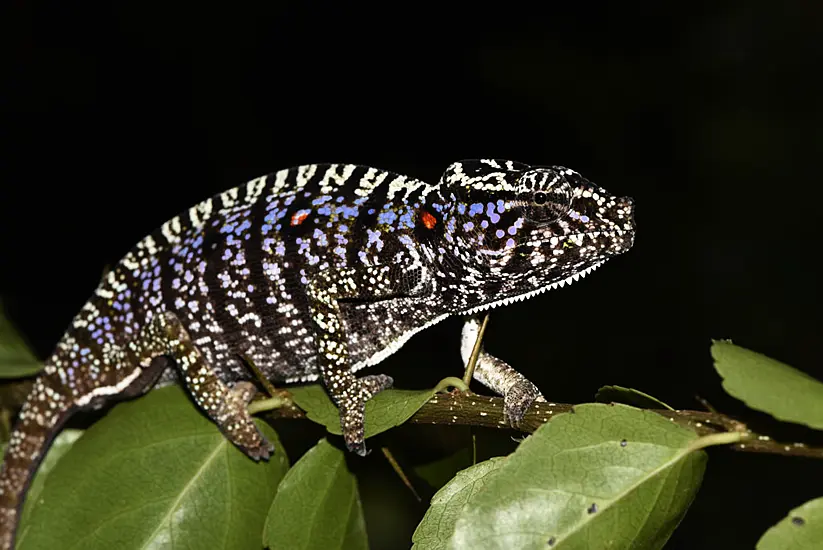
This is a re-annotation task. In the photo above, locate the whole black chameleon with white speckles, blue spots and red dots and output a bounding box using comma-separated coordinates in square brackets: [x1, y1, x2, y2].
[0, 159, 635, 549]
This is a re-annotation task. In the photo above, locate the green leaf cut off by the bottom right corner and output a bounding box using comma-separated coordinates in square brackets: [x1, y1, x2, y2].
[757, 497, 823, 550]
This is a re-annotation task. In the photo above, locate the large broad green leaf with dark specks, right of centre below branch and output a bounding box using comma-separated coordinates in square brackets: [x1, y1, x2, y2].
[444, 403, 716, 550]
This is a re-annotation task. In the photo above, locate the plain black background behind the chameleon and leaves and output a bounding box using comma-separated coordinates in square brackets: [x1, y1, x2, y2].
[0, 0, 823, 548]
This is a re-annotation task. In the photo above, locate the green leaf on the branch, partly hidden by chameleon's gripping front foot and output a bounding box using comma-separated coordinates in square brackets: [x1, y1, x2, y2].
[289, 384, 438, 437]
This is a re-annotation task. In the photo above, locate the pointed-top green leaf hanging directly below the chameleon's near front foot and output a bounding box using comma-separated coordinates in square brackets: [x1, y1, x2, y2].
[263, 439, 369, 550]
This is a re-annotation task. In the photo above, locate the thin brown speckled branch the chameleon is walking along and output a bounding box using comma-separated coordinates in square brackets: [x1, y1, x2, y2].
[266, 390, 823, 459]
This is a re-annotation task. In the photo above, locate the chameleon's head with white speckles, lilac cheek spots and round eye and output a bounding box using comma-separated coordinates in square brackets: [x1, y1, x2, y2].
[434, 159, 635, 312]
